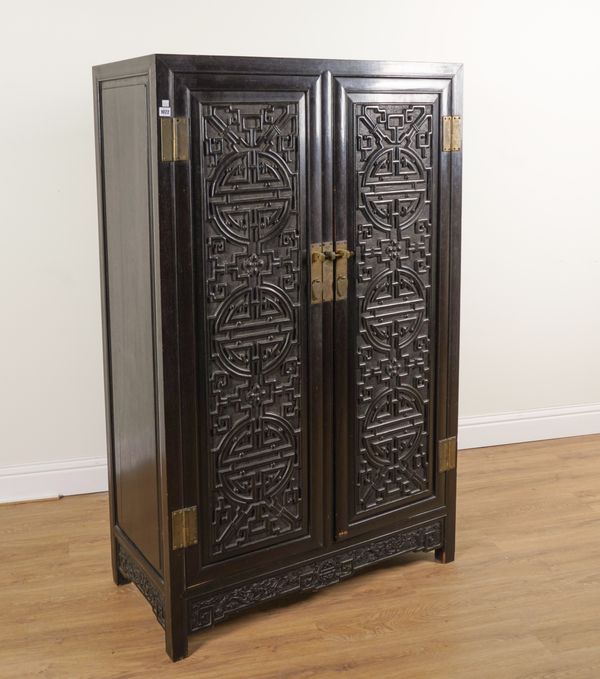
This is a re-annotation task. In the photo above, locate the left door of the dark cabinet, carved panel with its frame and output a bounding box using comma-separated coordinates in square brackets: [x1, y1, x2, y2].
[175, 74, 323, 585]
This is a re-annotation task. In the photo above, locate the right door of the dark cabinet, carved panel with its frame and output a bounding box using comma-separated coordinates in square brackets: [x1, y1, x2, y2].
[334, 78, 450, 540]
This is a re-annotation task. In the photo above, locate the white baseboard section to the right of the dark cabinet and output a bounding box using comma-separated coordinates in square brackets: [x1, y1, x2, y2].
[458, 403, 600, 448]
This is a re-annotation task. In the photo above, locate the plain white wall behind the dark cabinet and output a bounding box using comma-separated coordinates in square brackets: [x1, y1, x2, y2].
[0, 0, 600, 497]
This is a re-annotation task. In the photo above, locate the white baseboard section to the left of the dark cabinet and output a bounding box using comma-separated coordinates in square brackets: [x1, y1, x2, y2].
[0, 457, 108, 503]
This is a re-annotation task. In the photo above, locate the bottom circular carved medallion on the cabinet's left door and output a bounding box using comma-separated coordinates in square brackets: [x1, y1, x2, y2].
[217, 415, 296, 504]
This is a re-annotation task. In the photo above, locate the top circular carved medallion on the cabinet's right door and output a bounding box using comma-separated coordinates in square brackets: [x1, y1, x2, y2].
[360, 146, 427, 231]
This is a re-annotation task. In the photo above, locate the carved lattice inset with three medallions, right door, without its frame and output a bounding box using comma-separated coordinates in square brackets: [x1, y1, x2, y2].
[353, 103, 436, 515]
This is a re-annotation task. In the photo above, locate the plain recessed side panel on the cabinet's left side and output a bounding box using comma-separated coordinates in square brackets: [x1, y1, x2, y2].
[101, 77, 162, 572]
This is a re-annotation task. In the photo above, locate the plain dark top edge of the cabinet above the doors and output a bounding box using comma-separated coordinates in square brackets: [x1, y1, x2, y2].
[93, 54, 462, 79]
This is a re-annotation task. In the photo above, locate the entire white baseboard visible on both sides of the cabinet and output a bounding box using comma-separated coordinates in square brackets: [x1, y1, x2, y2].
[0, 403, 600, 503]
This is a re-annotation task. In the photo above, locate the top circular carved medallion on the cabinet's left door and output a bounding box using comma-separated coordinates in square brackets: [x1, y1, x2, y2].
[209, 149, 294, 243]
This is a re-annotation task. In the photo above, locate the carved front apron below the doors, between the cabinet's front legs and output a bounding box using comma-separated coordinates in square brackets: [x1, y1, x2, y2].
[188, 519, 443, 632]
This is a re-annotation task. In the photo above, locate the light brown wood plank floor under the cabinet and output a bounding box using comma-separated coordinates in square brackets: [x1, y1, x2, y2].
[0, 436, 600, 679]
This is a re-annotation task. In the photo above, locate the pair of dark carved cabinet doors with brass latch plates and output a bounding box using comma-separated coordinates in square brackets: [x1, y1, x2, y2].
[172, 62, 456, 586]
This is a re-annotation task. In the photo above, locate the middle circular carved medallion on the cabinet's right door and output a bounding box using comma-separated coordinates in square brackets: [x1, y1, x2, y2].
[362, 269, 425, 351]
